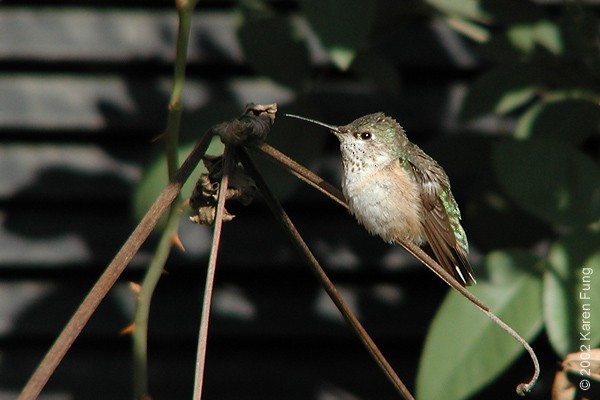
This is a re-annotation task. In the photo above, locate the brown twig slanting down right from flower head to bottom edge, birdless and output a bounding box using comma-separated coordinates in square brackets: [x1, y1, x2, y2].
[237, 148, 414, 400]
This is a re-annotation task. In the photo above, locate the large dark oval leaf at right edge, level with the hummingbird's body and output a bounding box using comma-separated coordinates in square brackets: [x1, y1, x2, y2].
[492, 140, 600, 226]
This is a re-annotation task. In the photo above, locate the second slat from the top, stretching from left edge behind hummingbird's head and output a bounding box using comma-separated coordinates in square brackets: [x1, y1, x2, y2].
[0, 75, 498, 137]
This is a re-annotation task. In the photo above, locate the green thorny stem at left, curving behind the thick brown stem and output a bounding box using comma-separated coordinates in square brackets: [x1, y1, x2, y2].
[132, 1, 196, 400]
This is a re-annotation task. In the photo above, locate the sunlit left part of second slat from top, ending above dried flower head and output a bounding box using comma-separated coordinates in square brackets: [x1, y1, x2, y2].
[0, 74, 291, 131]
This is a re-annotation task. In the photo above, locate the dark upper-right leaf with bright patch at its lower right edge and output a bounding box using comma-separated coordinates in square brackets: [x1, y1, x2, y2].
[460, 63, 539, 121]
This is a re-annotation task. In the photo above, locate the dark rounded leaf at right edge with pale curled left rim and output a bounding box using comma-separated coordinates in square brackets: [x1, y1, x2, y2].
[515, 93, 600, 144]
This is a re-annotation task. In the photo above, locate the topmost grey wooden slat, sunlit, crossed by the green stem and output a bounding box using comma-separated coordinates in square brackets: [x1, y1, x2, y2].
[0, 8, 242, 63]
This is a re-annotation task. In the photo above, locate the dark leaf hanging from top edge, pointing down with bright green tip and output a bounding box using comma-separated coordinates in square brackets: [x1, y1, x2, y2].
[300, 0, 375, 70]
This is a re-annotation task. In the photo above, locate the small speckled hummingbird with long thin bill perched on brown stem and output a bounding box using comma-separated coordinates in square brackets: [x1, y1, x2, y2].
[286, 112, 476, 286]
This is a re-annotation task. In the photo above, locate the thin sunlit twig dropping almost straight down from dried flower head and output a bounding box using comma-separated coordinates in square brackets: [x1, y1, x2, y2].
[193, 145, 233, 400]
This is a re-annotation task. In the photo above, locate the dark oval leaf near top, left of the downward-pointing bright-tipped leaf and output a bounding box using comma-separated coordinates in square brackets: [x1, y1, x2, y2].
[238, 6, 311, 87]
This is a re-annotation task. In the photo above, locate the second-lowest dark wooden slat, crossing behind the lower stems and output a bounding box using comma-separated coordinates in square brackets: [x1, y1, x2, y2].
[0, 276, 442, 342]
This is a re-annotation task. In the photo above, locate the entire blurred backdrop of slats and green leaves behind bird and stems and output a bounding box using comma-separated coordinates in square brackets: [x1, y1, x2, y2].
[0, 0, 600, 400]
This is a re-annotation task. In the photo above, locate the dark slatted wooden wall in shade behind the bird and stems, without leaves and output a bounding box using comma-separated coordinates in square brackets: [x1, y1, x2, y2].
[0, 1, 592, 400]
